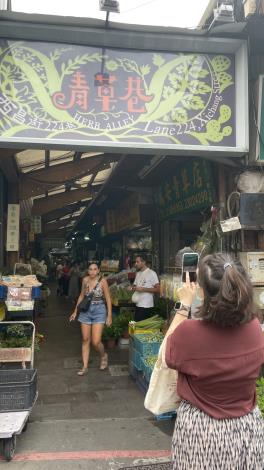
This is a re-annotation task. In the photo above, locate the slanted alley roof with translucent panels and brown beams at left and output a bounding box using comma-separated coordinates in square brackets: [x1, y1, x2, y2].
[0, 149, 118, 237]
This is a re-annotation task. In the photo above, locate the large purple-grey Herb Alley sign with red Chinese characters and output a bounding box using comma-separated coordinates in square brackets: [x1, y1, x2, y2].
[0, 40, 246, 152]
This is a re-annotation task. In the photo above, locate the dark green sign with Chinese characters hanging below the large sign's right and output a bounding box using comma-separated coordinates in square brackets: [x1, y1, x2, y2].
[156, 159, 215, 220]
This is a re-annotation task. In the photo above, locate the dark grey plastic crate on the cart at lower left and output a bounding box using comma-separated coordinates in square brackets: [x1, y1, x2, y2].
[0, 369, 37, 412]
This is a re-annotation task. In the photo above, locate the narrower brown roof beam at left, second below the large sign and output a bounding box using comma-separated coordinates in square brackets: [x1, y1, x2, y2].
[32, 189, 94, 215]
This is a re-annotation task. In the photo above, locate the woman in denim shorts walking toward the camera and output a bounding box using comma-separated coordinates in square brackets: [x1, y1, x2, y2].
[70, 263, 112, 376]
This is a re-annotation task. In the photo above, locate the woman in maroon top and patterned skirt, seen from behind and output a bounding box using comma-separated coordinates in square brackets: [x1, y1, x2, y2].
[166, 254, 264, 470]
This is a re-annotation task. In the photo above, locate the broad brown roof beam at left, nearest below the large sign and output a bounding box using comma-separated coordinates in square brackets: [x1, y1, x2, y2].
[19, 155, 112, 199]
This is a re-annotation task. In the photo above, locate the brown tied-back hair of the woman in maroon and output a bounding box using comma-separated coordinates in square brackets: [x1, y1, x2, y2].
[197, 253, 257, 327]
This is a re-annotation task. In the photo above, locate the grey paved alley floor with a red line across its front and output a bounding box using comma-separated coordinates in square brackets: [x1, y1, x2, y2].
[0, 288, 174, 470]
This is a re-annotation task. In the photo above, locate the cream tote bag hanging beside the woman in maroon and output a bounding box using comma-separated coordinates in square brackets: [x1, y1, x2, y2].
[144, 338, 181, 415]
